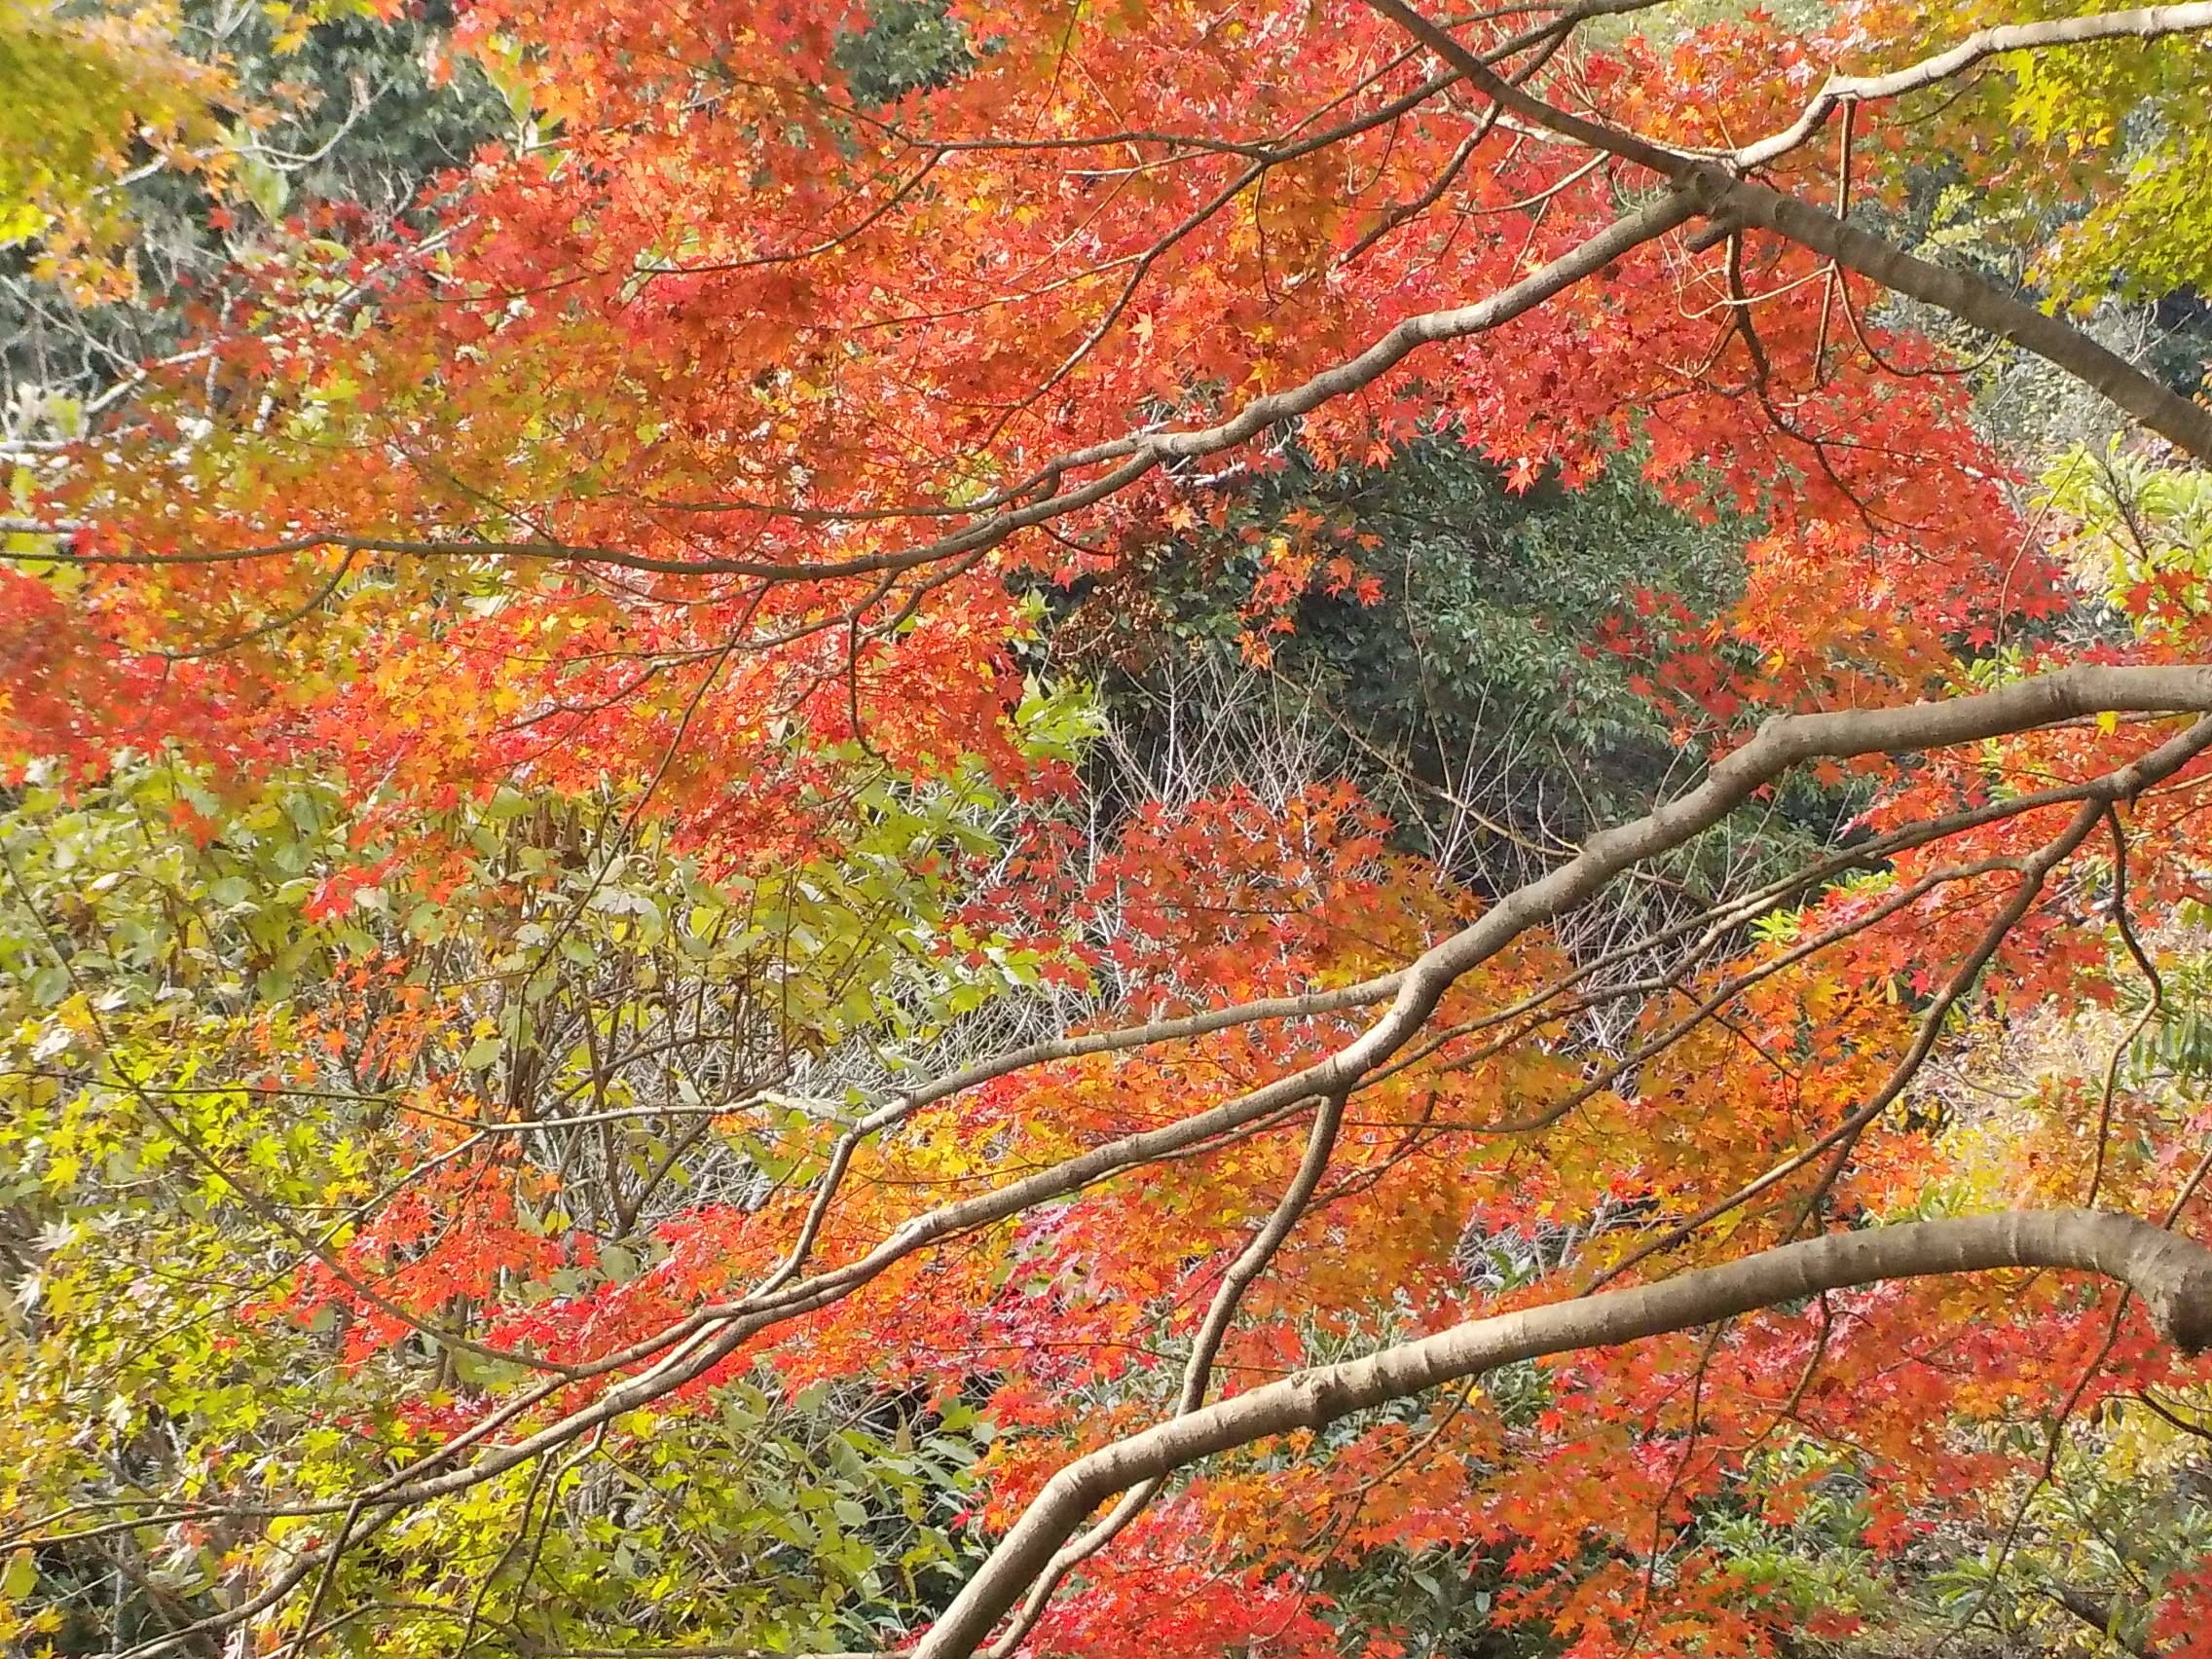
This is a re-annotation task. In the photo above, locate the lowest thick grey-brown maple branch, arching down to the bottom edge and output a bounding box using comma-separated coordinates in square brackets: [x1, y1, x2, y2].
[913, 1210, 2212, 1659]
